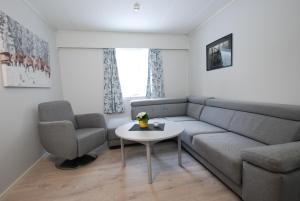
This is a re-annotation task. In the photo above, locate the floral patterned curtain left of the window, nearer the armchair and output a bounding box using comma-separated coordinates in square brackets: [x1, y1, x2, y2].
[103, 48, 124, 114]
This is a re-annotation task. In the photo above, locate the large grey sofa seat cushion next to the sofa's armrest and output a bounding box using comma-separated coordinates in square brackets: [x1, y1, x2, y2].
[192, 132, 266, 185]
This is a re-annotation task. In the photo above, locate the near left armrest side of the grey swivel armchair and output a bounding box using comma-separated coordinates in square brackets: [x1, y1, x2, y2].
[39, 120, 77, 160]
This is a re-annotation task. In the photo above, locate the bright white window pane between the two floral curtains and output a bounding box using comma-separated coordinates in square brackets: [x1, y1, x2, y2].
[116, 48, 148, 97]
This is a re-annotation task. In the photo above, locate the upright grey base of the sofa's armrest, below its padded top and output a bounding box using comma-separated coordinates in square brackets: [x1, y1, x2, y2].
[242, 161, 300, 201]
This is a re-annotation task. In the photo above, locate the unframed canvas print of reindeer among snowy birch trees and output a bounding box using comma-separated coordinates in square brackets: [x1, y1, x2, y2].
[0, 11, 51, 87]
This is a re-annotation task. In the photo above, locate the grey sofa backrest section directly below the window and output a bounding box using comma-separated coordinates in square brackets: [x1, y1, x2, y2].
[131, 98, 187, 119]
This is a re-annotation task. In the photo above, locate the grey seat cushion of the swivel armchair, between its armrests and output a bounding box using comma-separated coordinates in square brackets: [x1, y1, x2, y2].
[75, 128, 106, 157]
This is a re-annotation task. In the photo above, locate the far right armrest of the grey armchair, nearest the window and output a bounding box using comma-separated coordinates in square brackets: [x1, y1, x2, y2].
[75, 113, 106, 129]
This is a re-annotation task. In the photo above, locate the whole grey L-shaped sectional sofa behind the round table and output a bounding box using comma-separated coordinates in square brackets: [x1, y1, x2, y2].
[108, 97, 300, 201]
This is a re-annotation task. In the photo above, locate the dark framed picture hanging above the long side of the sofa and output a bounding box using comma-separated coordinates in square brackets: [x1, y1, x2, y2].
[206, 34, 232, 71]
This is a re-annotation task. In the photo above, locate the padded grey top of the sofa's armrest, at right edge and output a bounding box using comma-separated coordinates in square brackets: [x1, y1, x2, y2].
[242, 142, 300, 173]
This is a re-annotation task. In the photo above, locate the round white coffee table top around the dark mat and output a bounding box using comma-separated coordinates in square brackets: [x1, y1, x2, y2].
[116, 121, 184, 142]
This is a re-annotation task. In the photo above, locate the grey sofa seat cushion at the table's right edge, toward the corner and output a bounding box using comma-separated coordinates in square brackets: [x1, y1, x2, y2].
[179, 121, 226, 146]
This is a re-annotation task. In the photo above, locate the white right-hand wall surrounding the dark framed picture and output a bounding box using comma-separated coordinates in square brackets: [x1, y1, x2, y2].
[189, 0, 300, 105]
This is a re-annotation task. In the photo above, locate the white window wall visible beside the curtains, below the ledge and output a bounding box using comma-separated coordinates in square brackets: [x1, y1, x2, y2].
[59, 48, 188, 115]
